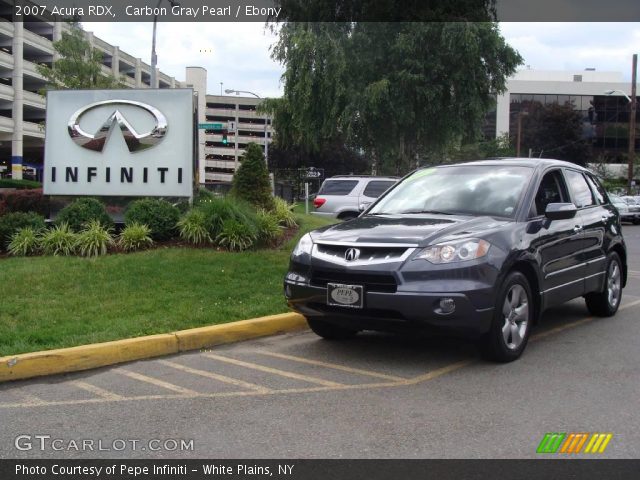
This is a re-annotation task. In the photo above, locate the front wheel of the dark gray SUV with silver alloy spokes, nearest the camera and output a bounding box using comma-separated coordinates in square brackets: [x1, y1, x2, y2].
[481, 272, 535, 363]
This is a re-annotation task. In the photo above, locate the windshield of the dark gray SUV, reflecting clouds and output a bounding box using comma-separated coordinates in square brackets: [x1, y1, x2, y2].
[369, 165, 533, 217]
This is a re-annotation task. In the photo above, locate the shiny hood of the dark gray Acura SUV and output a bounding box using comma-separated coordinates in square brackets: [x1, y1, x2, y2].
[311, 214, 508, 246]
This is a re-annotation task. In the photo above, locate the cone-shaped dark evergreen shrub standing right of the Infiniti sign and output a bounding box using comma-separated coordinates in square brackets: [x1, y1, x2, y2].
[231, 143, 273, 210]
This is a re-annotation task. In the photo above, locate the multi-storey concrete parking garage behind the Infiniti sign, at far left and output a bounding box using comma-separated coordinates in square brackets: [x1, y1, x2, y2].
[0, 0, 184, 178]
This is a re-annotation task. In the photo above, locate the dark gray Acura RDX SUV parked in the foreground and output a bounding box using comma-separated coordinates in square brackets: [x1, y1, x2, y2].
[284, 159, 627, 362]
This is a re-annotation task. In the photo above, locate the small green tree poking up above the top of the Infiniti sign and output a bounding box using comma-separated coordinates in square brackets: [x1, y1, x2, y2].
[36, 22, 122, 93]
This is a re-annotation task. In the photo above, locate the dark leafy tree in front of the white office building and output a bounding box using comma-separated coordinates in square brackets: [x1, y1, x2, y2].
[514, 102, 593, 165]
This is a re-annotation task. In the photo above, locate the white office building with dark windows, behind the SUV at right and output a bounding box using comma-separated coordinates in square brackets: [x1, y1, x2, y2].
[485, 68, 640, 171]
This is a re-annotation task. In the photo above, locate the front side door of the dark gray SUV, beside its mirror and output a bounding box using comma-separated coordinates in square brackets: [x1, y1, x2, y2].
[529, 168, 585, 306]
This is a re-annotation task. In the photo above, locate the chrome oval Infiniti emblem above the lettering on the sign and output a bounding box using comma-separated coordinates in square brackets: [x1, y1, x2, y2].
[67, 100, 167, 152]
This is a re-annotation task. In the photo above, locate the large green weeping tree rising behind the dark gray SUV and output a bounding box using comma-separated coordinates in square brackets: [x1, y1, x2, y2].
[265, 5, 522, 170]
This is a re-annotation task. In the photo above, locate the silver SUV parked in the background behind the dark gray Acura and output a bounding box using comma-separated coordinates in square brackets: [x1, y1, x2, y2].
[311, 175, 398, 220]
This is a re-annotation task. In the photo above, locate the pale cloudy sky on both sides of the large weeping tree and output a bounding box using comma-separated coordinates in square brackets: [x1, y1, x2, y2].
[84, 22, 640, 97]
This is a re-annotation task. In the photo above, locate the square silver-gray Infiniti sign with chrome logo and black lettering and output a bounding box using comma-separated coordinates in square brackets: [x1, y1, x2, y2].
[44, 89, 192, 197]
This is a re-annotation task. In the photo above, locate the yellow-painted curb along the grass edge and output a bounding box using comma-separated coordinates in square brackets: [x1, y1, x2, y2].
[0, 313, 307, 383]
